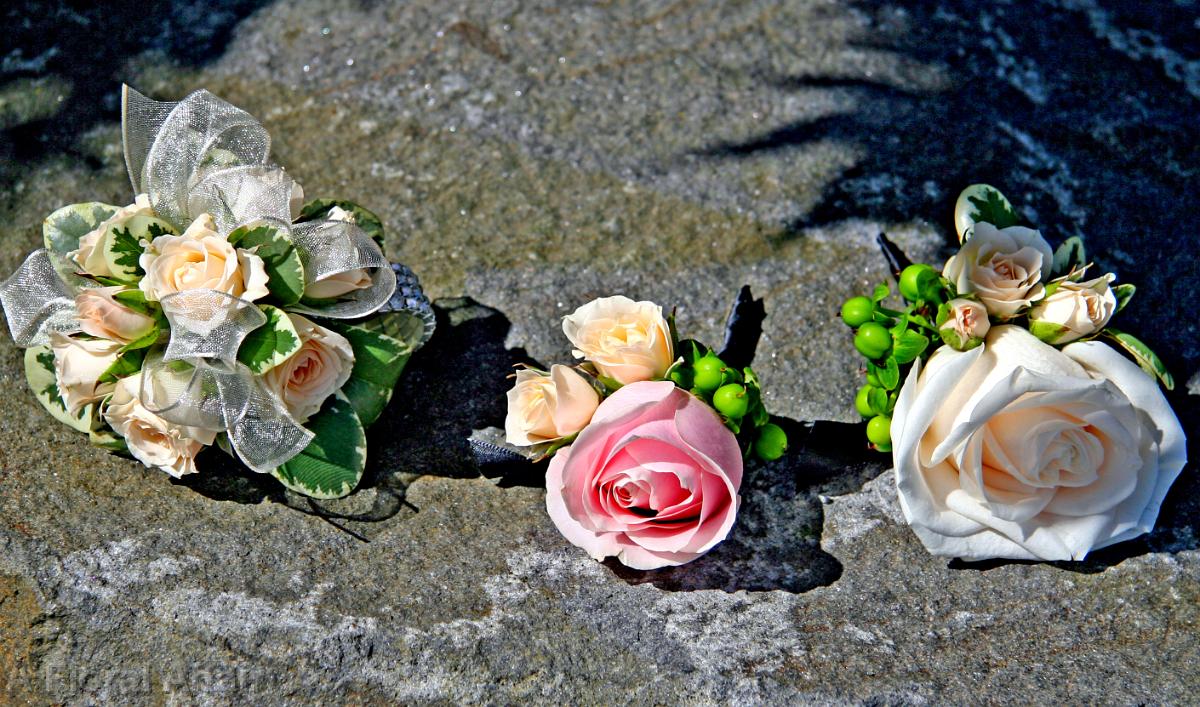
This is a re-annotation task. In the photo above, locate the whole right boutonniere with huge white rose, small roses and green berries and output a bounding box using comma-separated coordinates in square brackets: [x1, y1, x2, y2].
[841, 185, 1187, 561]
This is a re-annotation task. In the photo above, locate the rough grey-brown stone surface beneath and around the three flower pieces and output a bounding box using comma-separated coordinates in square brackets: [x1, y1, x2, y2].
[0, 0, 1200, 705]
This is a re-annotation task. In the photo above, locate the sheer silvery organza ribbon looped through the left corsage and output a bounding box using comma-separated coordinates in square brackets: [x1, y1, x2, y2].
[0, 86, 434, 472]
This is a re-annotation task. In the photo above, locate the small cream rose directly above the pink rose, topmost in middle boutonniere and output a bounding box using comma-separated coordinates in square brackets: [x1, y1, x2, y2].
[563, 295, 674, 385]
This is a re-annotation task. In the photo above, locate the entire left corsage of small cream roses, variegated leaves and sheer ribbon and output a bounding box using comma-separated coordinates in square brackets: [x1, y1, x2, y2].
[0, 86, 434, 497]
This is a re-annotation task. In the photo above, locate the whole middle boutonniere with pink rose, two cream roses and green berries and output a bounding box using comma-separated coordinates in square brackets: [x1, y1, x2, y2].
[505, 289, 787, 569]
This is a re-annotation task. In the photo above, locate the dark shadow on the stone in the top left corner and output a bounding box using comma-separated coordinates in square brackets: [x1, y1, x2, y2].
[0, 0, 265, 179]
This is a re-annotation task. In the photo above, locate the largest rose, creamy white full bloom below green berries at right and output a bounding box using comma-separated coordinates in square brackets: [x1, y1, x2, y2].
[892, 325, 1187, 561]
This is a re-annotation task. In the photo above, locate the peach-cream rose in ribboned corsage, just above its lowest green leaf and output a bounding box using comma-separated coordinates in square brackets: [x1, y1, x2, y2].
[263, 314, 354, 423]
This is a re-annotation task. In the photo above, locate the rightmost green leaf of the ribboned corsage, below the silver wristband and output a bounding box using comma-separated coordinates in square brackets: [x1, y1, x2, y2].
[329, 323, 413, 426]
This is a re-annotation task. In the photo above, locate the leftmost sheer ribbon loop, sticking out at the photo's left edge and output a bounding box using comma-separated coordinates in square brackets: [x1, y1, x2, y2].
[0, 248, 80, 348]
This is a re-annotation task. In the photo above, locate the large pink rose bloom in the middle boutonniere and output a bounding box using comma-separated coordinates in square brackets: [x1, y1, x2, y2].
[546, 381, 742, 569]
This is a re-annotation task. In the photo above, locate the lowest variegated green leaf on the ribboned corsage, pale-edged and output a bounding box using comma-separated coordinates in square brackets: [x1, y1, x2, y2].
[271, 393, 367, 498]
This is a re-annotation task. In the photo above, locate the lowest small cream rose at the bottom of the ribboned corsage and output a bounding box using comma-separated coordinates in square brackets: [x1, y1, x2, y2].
[104, 373, 216, 479]
